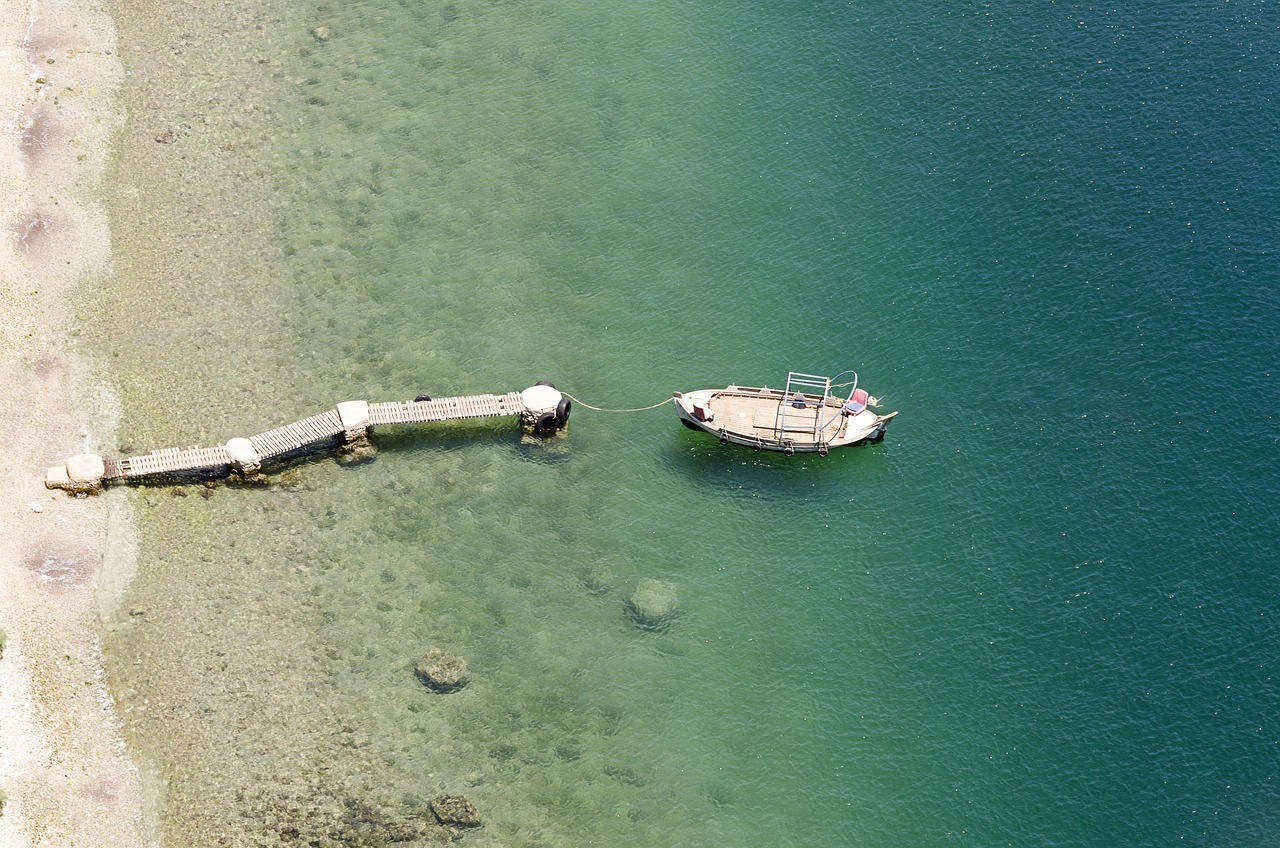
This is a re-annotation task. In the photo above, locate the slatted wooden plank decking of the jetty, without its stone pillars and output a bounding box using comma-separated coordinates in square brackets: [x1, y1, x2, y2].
[102, 392, 526, 480]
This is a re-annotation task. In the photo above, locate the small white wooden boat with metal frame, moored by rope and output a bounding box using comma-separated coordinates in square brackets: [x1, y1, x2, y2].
[672, 371, 897, 456]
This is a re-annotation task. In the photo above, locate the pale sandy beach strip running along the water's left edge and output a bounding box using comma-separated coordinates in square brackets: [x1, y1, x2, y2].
[0, 0, 150, 848]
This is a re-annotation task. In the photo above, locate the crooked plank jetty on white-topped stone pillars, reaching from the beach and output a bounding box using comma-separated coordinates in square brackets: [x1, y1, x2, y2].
[45, 382, 572, 494]
